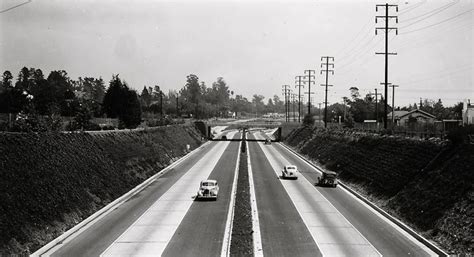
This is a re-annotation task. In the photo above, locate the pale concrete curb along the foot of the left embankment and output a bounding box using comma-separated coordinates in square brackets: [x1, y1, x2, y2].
[30, 141, 210, 257]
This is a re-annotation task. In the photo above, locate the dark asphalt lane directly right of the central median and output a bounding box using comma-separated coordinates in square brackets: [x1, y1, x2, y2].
[248, 135, 321, 256]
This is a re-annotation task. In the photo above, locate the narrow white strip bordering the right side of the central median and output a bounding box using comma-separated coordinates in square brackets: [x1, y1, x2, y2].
[245, 142, 263, 257]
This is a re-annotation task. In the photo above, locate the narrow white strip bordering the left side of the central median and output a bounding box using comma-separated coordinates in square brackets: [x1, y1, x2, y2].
[221, 133, 242, 257]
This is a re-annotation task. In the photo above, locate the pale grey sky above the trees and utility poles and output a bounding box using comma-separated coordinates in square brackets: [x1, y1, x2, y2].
[0, 0, 474, 106]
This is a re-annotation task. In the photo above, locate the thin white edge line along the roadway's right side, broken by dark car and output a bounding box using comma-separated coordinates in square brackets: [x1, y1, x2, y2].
[282, 143, 438, 256]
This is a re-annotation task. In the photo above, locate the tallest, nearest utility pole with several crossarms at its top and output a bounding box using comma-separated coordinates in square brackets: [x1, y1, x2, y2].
[375, 4, 398, 129]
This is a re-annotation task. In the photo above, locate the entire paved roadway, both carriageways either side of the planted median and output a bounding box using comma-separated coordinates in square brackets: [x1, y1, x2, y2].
[43, 131, 435, 256]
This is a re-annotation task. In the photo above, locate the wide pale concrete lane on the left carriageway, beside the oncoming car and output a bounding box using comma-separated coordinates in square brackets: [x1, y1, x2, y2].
[101, 135, 235, 256]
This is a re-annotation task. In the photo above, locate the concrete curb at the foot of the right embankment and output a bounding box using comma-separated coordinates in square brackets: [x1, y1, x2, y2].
[280, 143, 449, 256]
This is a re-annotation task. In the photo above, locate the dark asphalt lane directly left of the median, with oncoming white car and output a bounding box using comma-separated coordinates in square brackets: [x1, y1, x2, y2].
[162, 133, 241, 257]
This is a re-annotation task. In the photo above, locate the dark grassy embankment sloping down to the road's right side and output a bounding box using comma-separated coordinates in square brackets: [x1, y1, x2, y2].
[285, 127, 474, 254]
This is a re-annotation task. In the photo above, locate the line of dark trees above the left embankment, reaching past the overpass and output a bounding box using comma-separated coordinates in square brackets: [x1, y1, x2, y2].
[0, 67, 285, 131]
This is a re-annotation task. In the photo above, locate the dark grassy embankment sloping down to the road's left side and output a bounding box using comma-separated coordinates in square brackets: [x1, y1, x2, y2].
[0, 126, 201, 256]
